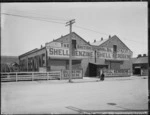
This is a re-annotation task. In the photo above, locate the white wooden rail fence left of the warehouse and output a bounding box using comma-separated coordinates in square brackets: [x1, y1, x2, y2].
[1, 71, 61, 82]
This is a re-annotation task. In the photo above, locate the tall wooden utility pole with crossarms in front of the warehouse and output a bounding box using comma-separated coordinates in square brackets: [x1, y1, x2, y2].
[66, 19, 75, 82]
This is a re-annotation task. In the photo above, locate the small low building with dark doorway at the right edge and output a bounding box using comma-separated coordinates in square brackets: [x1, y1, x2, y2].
[132, 55, 148, 76]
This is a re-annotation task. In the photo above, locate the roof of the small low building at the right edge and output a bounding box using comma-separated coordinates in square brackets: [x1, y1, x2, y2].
[132, 56, 148, 64]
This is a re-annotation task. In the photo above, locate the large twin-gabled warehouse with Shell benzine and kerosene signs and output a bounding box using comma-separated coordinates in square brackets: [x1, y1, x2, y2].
[19, 32, 132, 77]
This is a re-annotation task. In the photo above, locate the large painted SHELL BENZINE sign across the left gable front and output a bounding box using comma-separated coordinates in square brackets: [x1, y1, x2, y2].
[46, 43, 94, 58]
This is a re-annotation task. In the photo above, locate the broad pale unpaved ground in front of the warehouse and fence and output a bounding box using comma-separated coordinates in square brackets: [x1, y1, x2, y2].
[1, 76, 148, 114]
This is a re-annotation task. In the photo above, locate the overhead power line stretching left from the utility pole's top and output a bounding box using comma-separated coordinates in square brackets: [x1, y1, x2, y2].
[1, 13, 65, 24]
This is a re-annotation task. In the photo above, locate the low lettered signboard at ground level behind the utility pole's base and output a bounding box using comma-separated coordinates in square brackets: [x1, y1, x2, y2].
[62, 70, 83, 79]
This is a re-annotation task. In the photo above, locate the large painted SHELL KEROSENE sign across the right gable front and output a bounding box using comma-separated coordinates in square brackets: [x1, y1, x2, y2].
[96, 47, 132, 60]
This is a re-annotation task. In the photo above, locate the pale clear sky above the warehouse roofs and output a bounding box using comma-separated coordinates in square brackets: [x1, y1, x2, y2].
[1, 2, 148, 57]
